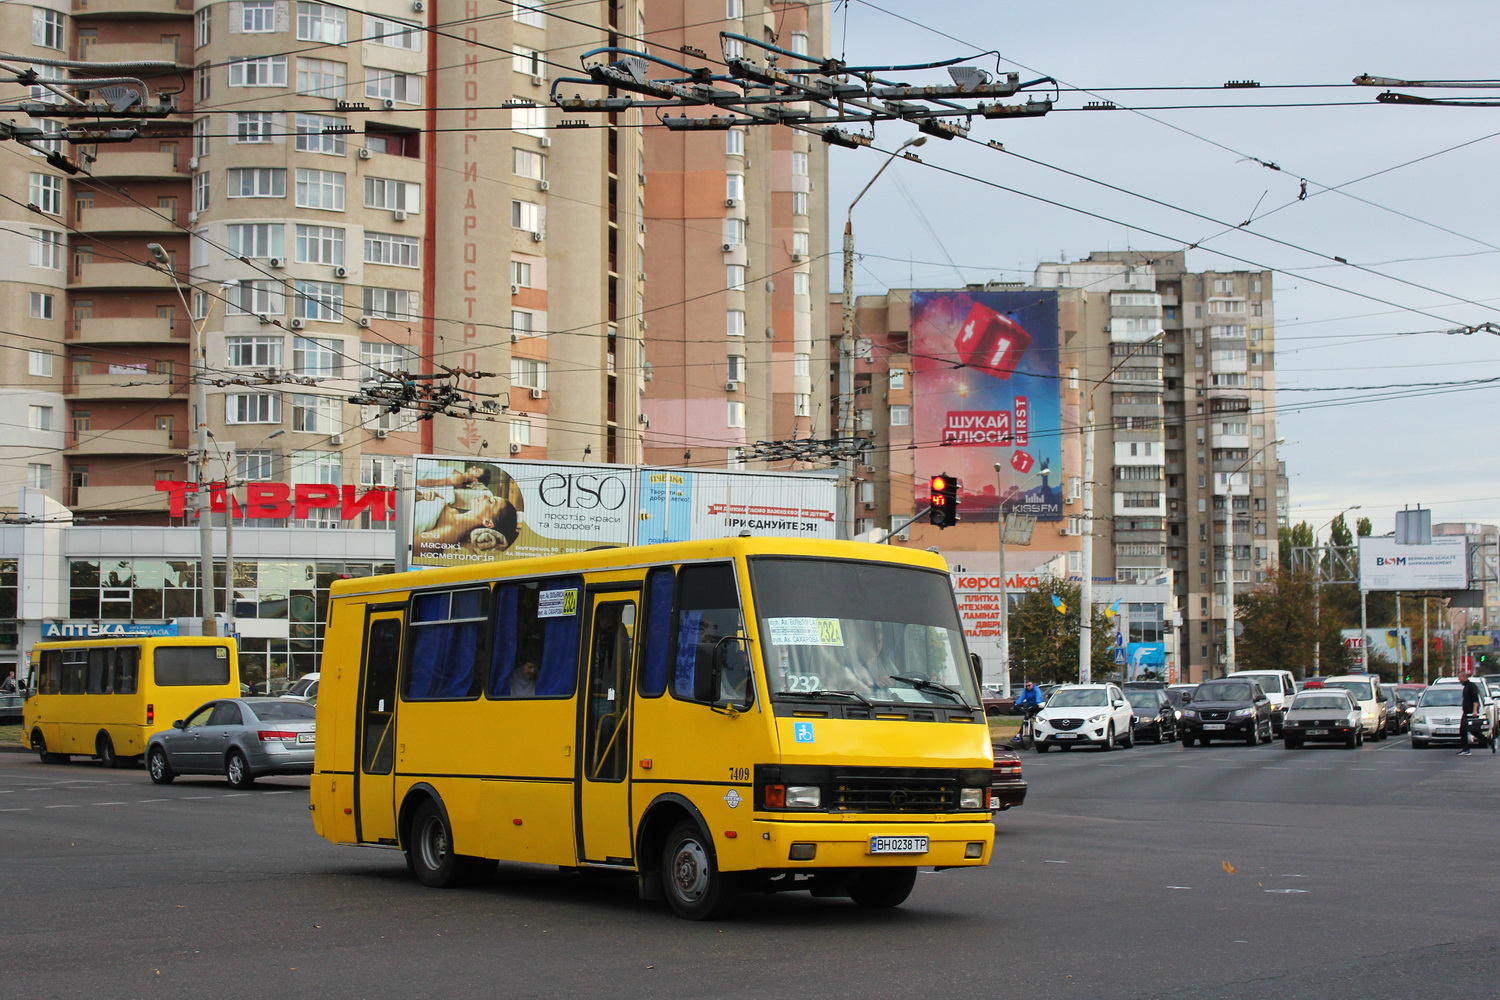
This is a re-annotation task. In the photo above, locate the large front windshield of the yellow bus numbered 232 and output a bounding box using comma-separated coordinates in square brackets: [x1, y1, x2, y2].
[750, 556, 980, 708]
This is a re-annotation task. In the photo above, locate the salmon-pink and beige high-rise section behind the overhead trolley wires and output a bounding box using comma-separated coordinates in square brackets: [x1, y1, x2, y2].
[641, 0, 831, 468]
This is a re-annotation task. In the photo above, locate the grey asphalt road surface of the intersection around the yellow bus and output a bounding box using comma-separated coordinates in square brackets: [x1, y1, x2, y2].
[0, 738, 1500, 1000]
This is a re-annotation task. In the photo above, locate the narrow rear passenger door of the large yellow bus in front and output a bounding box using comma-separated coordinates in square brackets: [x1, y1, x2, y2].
[354, 610, 404, 844]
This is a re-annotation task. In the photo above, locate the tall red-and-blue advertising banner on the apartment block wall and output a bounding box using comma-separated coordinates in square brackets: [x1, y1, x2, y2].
[911, 289, 1064, 522]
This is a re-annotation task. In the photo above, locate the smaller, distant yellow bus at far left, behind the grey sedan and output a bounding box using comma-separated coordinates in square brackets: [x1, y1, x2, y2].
[21, 636, 240, 768]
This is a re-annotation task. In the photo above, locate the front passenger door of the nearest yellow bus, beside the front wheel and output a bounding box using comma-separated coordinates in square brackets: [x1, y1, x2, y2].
[578, 591, 638, 865]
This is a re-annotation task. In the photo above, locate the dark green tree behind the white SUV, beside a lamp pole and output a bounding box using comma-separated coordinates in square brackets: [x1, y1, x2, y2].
[1010, 579, 1118, 684]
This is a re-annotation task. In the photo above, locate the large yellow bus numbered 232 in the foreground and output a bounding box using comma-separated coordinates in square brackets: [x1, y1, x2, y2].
[311, 538, 995, 919]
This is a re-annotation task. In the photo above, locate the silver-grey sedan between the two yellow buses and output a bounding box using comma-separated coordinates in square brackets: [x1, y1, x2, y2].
[146, 697, 317, 789]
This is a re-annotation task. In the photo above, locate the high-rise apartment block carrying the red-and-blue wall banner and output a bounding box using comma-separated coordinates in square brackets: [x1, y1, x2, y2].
[831, 252, 1287, 681]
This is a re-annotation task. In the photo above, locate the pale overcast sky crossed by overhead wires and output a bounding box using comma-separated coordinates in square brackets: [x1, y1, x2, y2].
[830, 0, 1500, 534]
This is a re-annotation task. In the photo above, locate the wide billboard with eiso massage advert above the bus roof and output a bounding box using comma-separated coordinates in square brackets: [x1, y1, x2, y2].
[411, 456, 839, 567]
